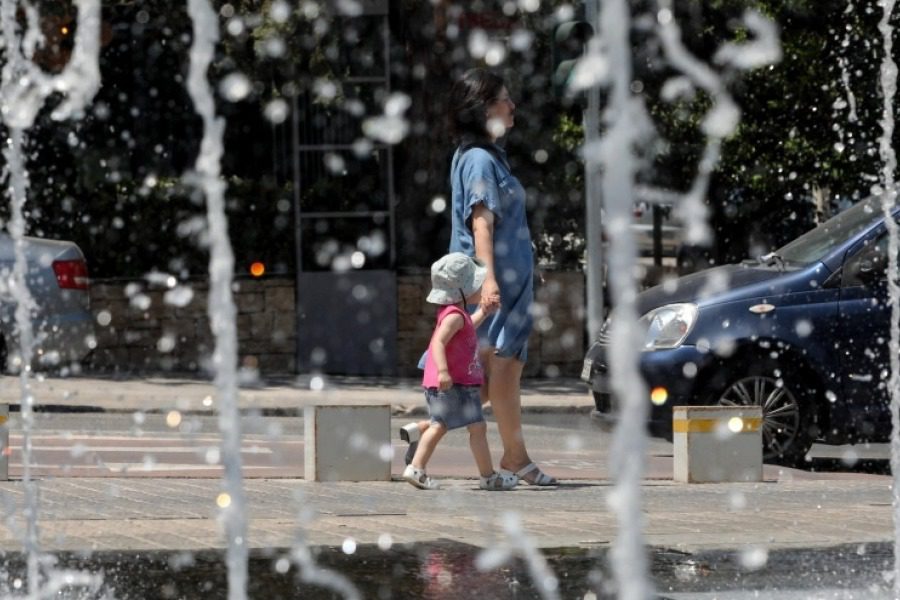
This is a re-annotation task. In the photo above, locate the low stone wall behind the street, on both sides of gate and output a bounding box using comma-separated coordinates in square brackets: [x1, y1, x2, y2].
[89, 273, 585, 376]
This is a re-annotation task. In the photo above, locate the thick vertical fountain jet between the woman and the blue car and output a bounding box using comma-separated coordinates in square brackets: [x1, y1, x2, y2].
[585, 0, 653, 600]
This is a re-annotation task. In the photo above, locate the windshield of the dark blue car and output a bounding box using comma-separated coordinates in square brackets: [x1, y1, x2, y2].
[775, 196, 882, 264]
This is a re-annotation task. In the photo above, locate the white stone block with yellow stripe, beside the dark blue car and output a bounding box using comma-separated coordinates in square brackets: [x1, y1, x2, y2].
[672, 406, 762, 483]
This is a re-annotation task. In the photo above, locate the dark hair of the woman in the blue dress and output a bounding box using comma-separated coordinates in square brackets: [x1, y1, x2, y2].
[447, 69, 505, 141]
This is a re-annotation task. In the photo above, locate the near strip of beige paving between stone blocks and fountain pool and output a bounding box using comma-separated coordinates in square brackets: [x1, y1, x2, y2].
[0, 478, 894, 552]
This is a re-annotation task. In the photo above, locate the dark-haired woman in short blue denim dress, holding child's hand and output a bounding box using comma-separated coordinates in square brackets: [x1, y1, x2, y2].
[449, 69, 557, 486]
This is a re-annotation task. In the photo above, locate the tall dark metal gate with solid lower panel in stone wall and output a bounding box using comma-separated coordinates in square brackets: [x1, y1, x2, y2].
[292, 0, 397, 375]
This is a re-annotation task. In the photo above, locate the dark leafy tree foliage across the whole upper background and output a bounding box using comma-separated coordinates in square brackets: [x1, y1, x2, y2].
[8, 0, 900, 276]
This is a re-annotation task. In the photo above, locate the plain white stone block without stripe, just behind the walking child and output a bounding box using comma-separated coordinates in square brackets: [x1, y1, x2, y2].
[303, 404, 392, 481]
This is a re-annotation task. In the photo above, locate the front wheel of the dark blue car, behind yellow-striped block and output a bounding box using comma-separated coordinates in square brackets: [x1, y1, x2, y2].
[715, 371, 812, 466]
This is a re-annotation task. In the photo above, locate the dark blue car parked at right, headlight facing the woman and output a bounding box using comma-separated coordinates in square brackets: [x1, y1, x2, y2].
[582, 197, 891, 464]
